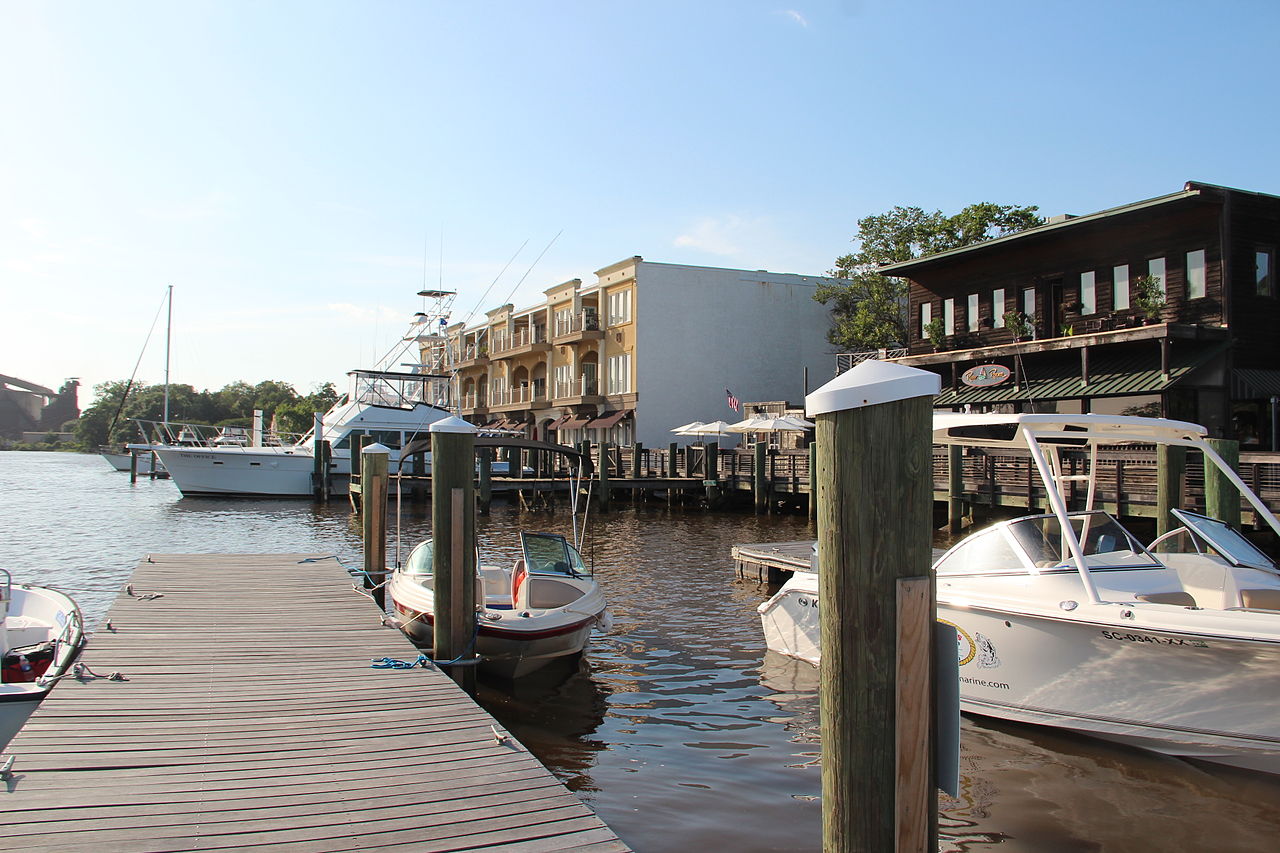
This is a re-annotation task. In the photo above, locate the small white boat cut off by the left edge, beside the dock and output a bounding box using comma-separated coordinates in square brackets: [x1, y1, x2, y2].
[0, 569, 84, 747]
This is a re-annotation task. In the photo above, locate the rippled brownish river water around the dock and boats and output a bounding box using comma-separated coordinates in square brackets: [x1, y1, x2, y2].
[0, 452, 1280, 853]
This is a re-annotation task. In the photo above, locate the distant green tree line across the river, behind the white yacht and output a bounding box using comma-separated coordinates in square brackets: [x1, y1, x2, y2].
[73, 379, 338, 447]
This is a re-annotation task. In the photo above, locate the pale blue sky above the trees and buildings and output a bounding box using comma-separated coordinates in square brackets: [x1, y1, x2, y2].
[0, 0, 1280, 401]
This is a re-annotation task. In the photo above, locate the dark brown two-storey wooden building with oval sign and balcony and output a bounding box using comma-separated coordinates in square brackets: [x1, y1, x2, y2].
[881, 182, 1280, 447]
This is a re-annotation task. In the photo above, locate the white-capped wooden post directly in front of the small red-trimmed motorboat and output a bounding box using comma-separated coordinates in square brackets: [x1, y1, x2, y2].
[430, 418, 478, 693]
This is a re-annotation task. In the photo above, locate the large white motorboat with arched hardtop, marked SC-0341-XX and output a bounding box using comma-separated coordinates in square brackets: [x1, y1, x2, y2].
[759, 414, 1280, 772]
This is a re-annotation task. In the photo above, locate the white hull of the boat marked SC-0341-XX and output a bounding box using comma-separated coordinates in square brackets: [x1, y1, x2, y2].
[759, 573, 1280, 774]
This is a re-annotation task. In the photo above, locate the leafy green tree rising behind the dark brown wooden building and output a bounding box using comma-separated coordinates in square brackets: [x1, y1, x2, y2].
[814, 201, 1044, 351]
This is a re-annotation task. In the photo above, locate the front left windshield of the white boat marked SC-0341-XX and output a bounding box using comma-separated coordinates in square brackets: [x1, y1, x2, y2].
[937, 512, 1161, 574]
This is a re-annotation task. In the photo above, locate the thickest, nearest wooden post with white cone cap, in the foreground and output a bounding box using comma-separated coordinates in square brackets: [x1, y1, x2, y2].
[806, 361, 940, 853]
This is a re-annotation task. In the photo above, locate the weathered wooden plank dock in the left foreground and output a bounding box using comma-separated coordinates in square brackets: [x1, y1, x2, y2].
[0, 555, 627, 853]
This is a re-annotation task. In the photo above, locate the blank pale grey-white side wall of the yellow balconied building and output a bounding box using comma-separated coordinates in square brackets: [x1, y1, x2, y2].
[632, 261, 835, 447]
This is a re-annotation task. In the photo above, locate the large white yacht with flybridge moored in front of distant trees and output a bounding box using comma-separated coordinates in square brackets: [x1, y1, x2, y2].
[152, 370, 449, 497]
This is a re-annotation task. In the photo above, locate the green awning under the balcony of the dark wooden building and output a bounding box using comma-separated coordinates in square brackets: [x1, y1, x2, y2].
[933, 343, 1229, 406]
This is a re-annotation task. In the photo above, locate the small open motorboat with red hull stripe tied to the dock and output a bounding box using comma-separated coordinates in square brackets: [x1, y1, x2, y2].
[388, 533, 609, 678]
